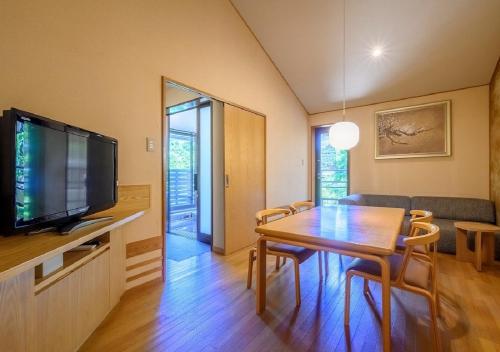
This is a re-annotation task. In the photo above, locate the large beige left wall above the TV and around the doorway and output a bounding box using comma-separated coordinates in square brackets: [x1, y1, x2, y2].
[0, 0, 307, 245]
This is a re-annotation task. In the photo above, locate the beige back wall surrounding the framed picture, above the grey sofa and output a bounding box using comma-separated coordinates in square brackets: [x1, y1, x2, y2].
[309, 85, 489, 198]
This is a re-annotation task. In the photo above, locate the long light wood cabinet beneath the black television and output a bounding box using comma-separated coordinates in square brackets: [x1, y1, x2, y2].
[0, 186, 150, 352]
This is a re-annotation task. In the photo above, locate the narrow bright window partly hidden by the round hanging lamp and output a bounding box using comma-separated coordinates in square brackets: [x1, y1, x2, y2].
[315, 127, 349, 206]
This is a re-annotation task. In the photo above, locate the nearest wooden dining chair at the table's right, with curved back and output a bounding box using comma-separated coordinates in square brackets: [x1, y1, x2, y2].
[344, 222, 441, 351]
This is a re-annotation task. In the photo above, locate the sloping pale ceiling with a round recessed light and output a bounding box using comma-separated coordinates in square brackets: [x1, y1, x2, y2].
[232, 0, 500, 113]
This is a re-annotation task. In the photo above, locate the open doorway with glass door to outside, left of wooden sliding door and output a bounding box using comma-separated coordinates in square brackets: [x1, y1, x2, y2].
[165, 97, 212, 262]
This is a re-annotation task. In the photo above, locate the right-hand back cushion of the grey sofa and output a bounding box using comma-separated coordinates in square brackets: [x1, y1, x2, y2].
[411, 197, 495, 223]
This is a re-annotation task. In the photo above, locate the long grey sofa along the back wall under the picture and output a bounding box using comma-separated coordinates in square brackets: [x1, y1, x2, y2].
[339, 194, 500, 259]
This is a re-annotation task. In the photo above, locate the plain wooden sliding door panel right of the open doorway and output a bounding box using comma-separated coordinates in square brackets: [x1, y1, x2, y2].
[224, 104, 266, 254]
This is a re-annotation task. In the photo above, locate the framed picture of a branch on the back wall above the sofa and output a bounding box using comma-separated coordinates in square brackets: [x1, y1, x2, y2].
[375, 100, 451, 159]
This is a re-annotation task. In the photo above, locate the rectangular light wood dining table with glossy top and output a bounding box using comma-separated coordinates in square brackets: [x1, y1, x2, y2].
[255, 205, 405, 352]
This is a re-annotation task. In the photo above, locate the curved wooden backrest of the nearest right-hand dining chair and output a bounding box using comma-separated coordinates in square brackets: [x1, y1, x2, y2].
[397, 222, 439, 288]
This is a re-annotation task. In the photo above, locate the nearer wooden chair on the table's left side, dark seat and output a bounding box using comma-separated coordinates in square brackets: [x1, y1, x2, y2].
[247, 208, 323, 307]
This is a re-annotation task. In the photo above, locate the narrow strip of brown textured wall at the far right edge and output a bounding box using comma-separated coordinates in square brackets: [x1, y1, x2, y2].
[490, 60, 500, 224]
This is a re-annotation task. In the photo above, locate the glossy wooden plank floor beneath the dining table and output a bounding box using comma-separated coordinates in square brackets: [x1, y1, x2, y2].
[81, 251, 500, 352]
